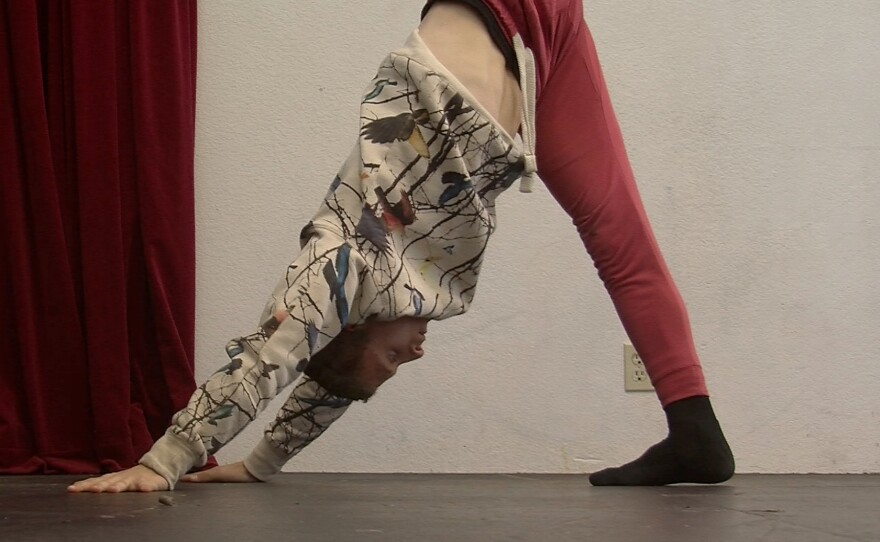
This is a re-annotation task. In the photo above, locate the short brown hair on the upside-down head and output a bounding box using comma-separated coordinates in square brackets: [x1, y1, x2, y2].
[304, 326, 373, 401]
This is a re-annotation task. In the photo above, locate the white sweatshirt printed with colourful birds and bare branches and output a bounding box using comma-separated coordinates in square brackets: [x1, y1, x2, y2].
[141, 31, 526, 488]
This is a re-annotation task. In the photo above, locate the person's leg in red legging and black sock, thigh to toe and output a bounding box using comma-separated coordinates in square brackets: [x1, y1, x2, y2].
[537, 20, 734, 485]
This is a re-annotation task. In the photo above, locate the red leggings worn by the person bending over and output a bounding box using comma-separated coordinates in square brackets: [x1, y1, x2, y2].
[428, 0, 708, 406]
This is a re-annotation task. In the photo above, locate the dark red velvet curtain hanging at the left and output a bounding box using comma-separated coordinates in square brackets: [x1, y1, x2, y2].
[0, 0, 196, 473]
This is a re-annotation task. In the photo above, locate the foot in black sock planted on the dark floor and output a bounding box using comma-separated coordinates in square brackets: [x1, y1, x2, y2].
[590, 397, 734, 486]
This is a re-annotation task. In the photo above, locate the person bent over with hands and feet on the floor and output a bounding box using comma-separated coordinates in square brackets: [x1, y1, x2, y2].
[68, 0, 734, 492]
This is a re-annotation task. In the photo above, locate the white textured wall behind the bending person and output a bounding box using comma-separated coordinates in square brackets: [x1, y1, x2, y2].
[196, 0, 880, 472]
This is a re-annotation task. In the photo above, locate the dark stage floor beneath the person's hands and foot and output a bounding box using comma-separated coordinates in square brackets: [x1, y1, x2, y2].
[0, 474, 880, 542]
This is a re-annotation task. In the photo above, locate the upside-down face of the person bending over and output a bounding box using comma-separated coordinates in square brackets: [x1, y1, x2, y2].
[346, 316, 428, 399]
